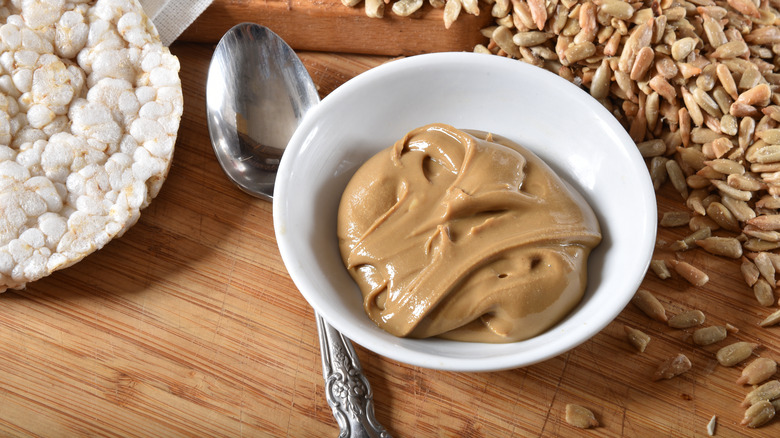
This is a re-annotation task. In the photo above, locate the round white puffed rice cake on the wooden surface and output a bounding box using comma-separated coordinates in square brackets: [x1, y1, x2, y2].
[0, 0, 183, 292]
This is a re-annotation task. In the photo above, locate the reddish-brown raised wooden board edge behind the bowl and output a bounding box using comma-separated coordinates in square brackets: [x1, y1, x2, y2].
[179, 0, 492, 56]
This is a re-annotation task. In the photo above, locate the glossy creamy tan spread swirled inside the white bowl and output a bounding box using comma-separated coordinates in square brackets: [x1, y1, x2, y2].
[338, 124, 601, 342]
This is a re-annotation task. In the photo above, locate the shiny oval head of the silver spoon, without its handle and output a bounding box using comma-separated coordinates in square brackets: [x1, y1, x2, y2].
[206, 23, 319, 197]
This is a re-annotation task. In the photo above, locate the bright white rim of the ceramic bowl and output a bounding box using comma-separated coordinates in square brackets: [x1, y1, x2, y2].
[273, 52, 657, 371]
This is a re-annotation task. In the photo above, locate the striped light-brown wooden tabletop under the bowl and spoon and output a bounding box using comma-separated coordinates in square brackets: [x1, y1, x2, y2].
[0, 7, 780, 437]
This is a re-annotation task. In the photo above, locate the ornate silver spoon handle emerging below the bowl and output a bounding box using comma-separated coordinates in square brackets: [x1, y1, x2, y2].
[315, 313, 390, 438]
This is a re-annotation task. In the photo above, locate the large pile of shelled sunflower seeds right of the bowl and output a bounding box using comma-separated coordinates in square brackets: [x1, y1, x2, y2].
[474, 0, 780, 307]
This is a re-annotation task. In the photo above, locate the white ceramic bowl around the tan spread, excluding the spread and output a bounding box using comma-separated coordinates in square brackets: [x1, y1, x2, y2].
[273, 53, 657, 371]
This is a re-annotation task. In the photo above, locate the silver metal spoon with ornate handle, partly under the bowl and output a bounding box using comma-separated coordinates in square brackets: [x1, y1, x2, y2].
[206, 23, 390, 437]
